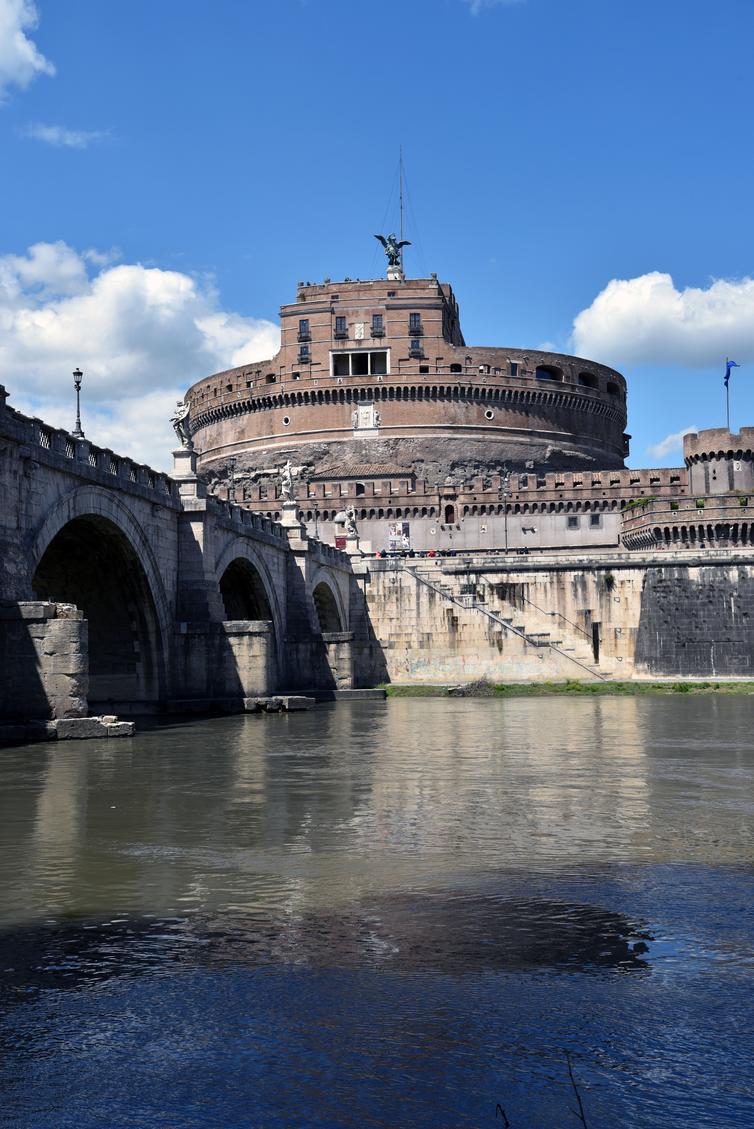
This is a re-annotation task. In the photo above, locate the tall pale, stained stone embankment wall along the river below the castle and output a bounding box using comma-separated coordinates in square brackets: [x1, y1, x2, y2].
[357, 551, 754, 683]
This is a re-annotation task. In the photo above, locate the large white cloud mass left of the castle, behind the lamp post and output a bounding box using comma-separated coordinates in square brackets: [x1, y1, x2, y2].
[0, 243, 280, 466]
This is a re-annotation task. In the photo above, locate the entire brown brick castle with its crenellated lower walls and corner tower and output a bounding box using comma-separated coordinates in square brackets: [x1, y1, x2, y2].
[186, 269, 754, 552]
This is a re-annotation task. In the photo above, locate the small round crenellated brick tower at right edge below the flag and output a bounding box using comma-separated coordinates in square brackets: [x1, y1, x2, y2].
[683, 427, 754, 496]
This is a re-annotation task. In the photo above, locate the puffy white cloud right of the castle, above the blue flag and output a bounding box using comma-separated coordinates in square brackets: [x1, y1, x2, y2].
[571, 271, 754, 368]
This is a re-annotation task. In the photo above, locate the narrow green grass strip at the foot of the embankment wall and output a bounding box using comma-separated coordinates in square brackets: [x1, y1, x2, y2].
[384, 679, 754, 698]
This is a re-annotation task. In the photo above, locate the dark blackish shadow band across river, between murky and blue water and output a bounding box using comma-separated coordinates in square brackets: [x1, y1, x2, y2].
[0, 891, 652, 999]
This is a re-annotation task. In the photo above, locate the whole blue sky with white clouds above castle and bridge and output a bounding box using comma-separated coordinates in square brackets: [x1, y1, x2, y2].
[0, 0, 754, 466]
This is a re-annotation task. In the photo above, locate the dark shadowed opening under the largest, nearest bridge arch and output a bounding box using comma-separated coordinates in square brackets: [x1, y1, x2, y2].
[32, 515, 165, 712]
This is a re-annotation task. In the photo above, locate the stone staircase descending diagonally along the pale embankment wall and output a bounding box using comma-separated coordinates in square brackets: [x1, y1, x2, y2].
[404, 561, 615, 681]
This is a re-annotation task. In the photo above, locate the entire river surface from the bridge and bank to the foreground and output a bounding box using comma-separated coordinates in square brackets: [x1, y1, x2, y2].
[0, 694, 754, 1129]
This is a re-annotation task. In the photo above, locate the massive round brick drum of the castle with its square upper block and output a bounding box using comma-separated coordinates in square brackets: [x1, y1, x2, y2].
[186, 277, 628, 481]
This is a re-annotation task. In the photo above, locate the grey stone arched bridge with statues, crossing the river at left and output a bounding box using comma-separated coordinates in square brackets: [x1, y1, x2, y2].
[0, 388, 363, 718]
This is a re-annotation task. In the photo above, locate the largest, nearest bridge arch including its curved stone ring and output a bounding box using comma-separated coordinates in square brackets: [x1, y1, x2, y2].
[29, 487, 170, 711]
